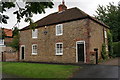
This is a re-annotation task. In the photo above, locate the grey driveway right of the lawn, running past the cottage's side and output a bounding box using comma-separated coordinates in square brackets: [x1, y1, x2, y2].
[73, 58, 120, 79]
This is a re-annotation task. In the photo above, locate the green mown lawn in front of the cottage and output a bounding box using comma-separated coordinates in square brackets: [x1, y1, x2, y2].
[2, 62, 80, 78]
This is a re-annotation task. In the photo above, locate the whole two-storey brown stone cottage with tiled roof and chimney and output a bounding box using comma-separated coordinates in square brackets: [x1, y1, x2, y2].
[19, 2, 109, 63]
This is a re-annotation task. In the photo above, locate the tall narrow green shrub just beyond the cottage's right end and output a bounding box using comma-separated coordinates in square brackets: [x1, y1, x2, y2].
[107, 30, 114, 57]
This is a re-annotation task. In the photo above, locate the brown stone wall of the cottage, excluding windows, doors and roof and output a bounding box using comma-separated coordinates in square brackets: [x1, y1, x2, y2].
[19, 19, 108, 63]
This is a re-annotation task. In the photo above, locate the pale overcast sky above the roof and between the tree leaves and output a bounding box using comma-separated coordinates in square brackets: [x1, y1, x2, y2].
[0, 0, 120, 29]
